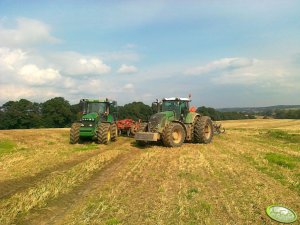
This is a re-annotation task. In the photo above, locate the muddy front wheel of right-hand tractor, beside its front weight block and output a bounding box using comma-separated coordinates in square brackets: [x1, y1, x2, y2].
[162, 123, 186, 147]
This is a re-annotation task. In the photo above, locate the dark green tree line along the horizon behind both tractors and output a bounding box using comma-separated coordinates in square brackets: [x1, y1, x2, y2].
[0, 97, 300, 129]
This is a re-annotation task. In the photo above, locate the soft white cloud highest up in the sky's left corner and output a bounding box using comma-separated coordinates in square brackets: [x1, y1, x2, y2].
[0, 18, 59, 47]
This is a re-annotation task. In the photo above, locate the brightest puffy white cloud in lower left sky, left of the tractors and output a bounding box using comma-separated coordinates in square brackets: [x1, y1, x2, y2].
[18, 64, 61, 85]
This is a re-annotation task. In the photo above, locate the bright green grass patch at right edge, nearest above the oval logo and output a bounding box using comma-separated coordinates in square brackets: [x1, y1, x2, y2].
[265, 152, 300, 169]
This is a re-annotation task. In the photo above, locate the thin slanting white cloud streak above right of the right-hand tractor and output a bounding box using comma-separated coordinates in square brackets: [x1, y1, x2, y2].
[184, 58, 258, 75]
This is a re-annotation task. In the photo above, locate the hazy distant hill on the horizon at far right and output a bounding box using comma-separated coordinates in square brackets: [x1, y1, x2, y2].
[217, 105, 300, 113]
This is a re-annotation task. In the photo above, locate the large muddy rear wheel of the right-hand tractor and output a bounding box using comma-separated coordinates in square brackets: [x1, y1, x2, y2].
[194, 116, 214, 144]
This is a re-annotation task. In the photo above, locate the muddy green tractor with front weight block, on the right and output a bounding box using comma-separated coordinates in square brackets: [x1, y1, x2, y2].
[135, 98, 213, 147]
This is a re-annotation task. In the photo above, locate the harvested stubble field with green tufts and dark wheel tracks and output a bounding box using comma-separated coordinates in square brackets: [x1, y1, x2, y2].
[0, 119, 300, 225]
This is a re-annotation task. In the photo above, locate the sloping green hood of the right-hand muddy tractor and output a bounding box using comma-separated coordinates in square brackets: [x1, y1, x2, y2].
[149, 111, 175, 132]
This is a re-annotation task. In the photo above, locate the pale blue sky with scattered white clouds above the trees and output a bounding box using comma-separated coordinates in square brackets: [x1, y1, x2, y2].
[0, 0, 300, 108]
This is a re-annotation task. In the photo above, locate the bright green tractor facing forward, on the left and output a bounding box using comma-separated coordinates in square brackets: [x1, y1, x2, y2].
[70, 99, 118, 144]
